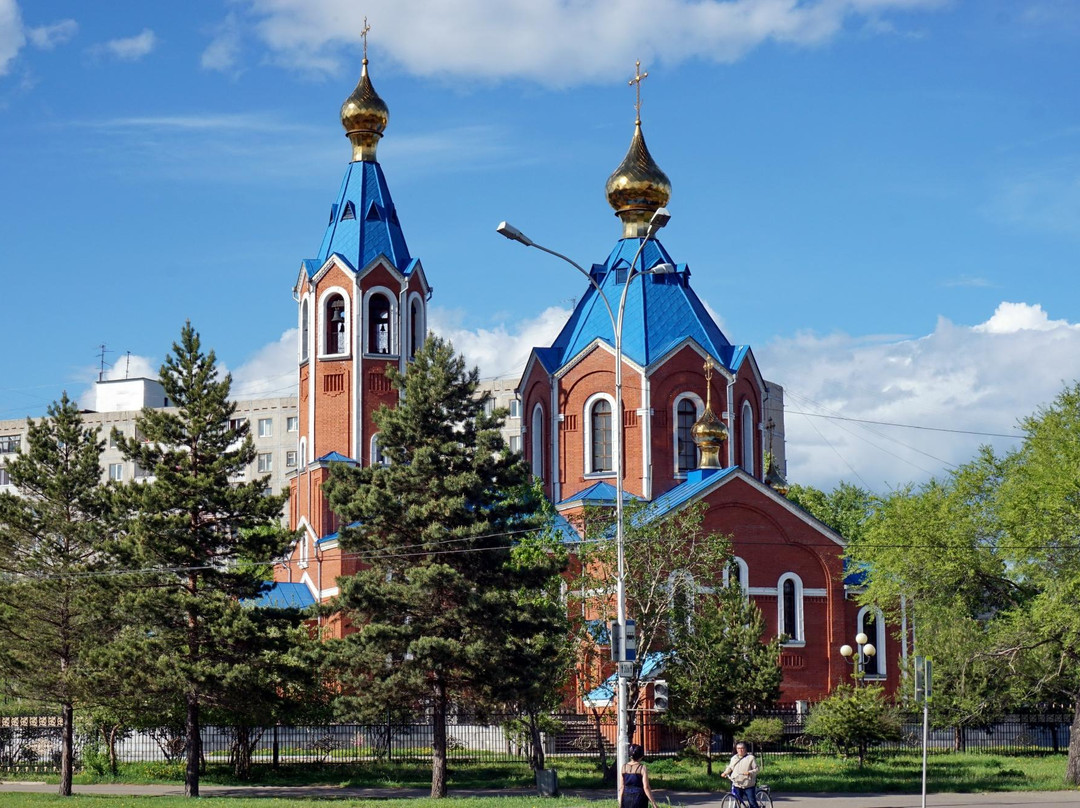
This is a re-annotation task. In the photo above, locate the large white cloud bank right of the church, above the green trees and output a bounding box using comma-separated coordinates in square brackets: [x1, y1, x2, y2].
[756, 302, 1080, 490]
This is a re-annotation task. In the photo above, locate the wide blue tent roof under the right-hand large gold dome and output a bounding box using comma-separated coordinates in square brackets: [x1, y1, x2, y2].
[538, 239, 746, 371]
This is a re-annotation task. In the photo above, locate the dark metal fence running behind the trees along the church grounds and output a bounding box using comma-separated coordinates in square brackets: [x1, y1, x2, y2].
[0, 712, 1070, 772]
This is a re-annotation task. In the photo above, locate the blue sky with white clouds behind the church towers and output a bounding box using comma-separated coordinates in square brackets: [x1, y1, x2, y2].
[0, 0, 1080, 489]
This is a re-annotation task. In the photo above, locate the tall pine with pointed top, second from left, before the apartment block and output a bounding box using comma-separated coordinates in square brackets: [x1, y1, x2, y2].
[113, 323, 292, 797]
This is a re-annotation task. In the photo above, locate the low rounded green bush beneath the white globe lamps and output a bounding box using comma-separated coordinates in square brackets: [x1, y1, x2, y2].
[806, 685, 903, 767]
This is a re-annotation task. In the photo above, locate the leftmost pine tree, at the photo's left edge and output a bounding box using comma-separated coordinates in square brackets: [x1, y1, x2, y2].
[0, 393, 113, 796]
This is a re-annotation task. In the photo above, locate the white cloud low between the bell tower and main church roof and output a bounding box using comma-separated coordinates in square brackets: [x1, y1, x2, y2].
[428, 306, 571, 378]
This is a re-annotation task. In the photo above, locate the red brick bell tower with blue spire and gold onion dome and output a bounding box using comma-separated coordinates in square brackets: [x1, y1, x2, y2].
[285, 33, 431, 601]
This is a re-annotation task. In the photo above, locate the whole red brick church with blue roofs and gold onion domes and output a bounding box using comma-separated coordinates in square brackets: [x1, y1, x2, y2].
[275, 54, 902, 703]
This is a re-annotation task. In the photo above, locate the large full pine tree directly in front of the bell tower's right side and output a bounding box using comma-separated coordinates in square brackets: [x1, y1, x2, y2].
[327, 337, 557, 797]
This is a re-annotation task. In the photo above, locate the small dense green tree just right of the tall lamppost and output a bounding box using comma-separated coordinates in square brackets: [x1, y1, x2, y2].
[664, 583, 783, 775]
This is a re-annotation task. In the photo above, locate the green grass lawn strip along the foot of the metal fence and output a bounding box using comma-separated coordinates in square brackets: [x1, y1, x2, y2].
[4, 753, 1065, 795]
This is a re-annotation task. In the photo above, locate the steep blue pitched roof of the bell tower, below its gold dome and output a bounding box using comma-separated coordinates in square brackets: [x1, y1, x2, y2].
[313, 161, 414, 274]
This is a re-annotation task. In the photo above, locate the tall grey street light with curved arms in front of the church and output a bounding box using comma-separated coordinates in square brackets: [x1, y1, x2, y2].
[496, 207, 674, 771]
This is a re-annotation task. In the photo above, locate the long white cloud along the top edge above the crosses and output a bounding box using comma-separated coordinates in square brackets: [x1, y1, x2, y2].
[236, 0, 946, 86]
